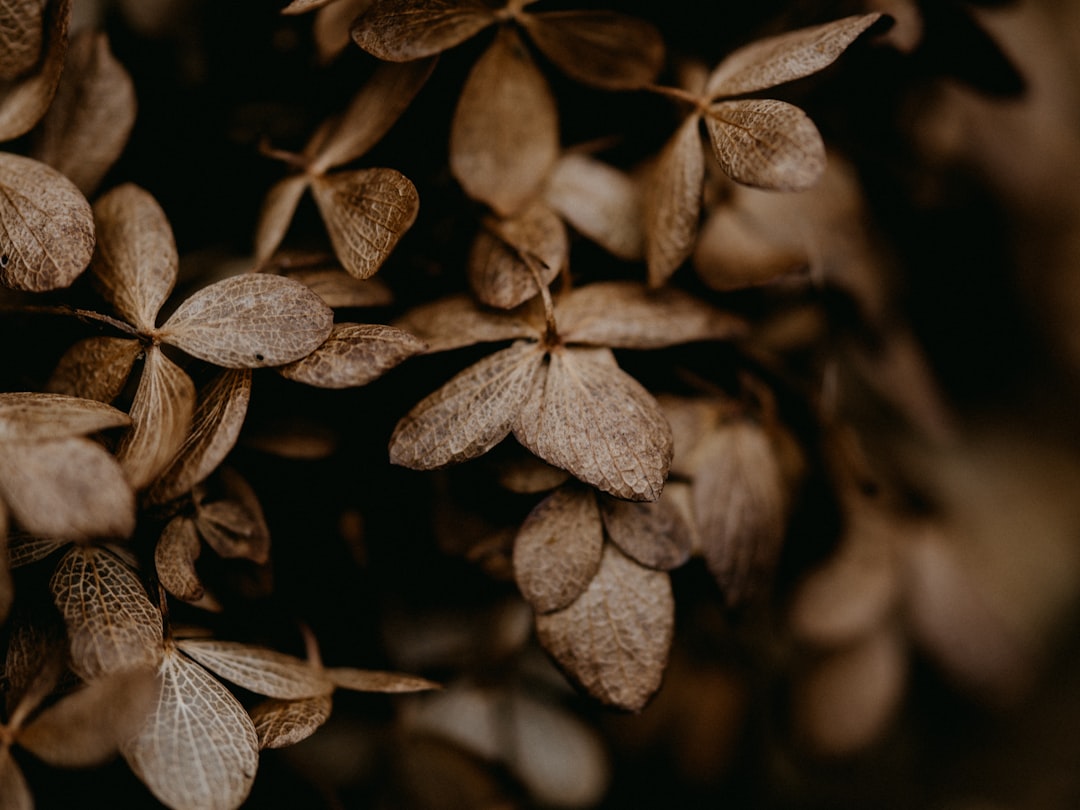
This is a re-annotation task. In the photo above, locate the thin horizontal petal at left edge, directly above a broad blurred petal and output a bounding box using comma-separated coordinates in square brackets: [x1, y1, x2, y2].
[0, 391, 131, 442]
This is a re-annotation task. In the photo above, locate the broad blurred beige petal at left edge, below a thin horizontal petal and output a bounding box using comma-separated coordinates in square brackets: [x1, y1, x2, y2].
[0, 437, 135, 540]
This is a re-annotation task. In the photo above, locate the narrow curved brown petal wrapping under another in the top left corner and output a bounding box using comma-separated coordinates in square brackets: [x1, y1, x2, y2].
[0, 0, 71, 141]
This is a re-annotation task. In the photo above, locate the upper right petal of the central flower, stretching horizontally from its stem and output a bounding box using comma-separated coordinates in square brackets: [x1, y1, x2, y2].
[555, 281, 747, 349]
